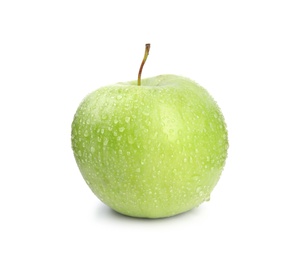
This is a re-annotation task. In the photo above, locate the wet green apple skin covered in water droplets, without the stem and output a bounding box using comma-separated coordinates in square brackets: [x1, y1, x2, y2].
[71, 75, 228, 218]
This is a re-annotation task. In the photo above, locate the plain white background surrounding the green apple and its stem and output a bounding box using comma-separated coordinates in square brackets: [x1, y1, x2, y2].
[0, 0, 306, 259]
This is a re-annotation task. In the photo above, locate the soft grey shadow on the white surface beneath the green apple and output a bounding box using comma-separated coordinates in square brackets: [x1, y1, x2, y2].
[95, 203, 207, 223]
